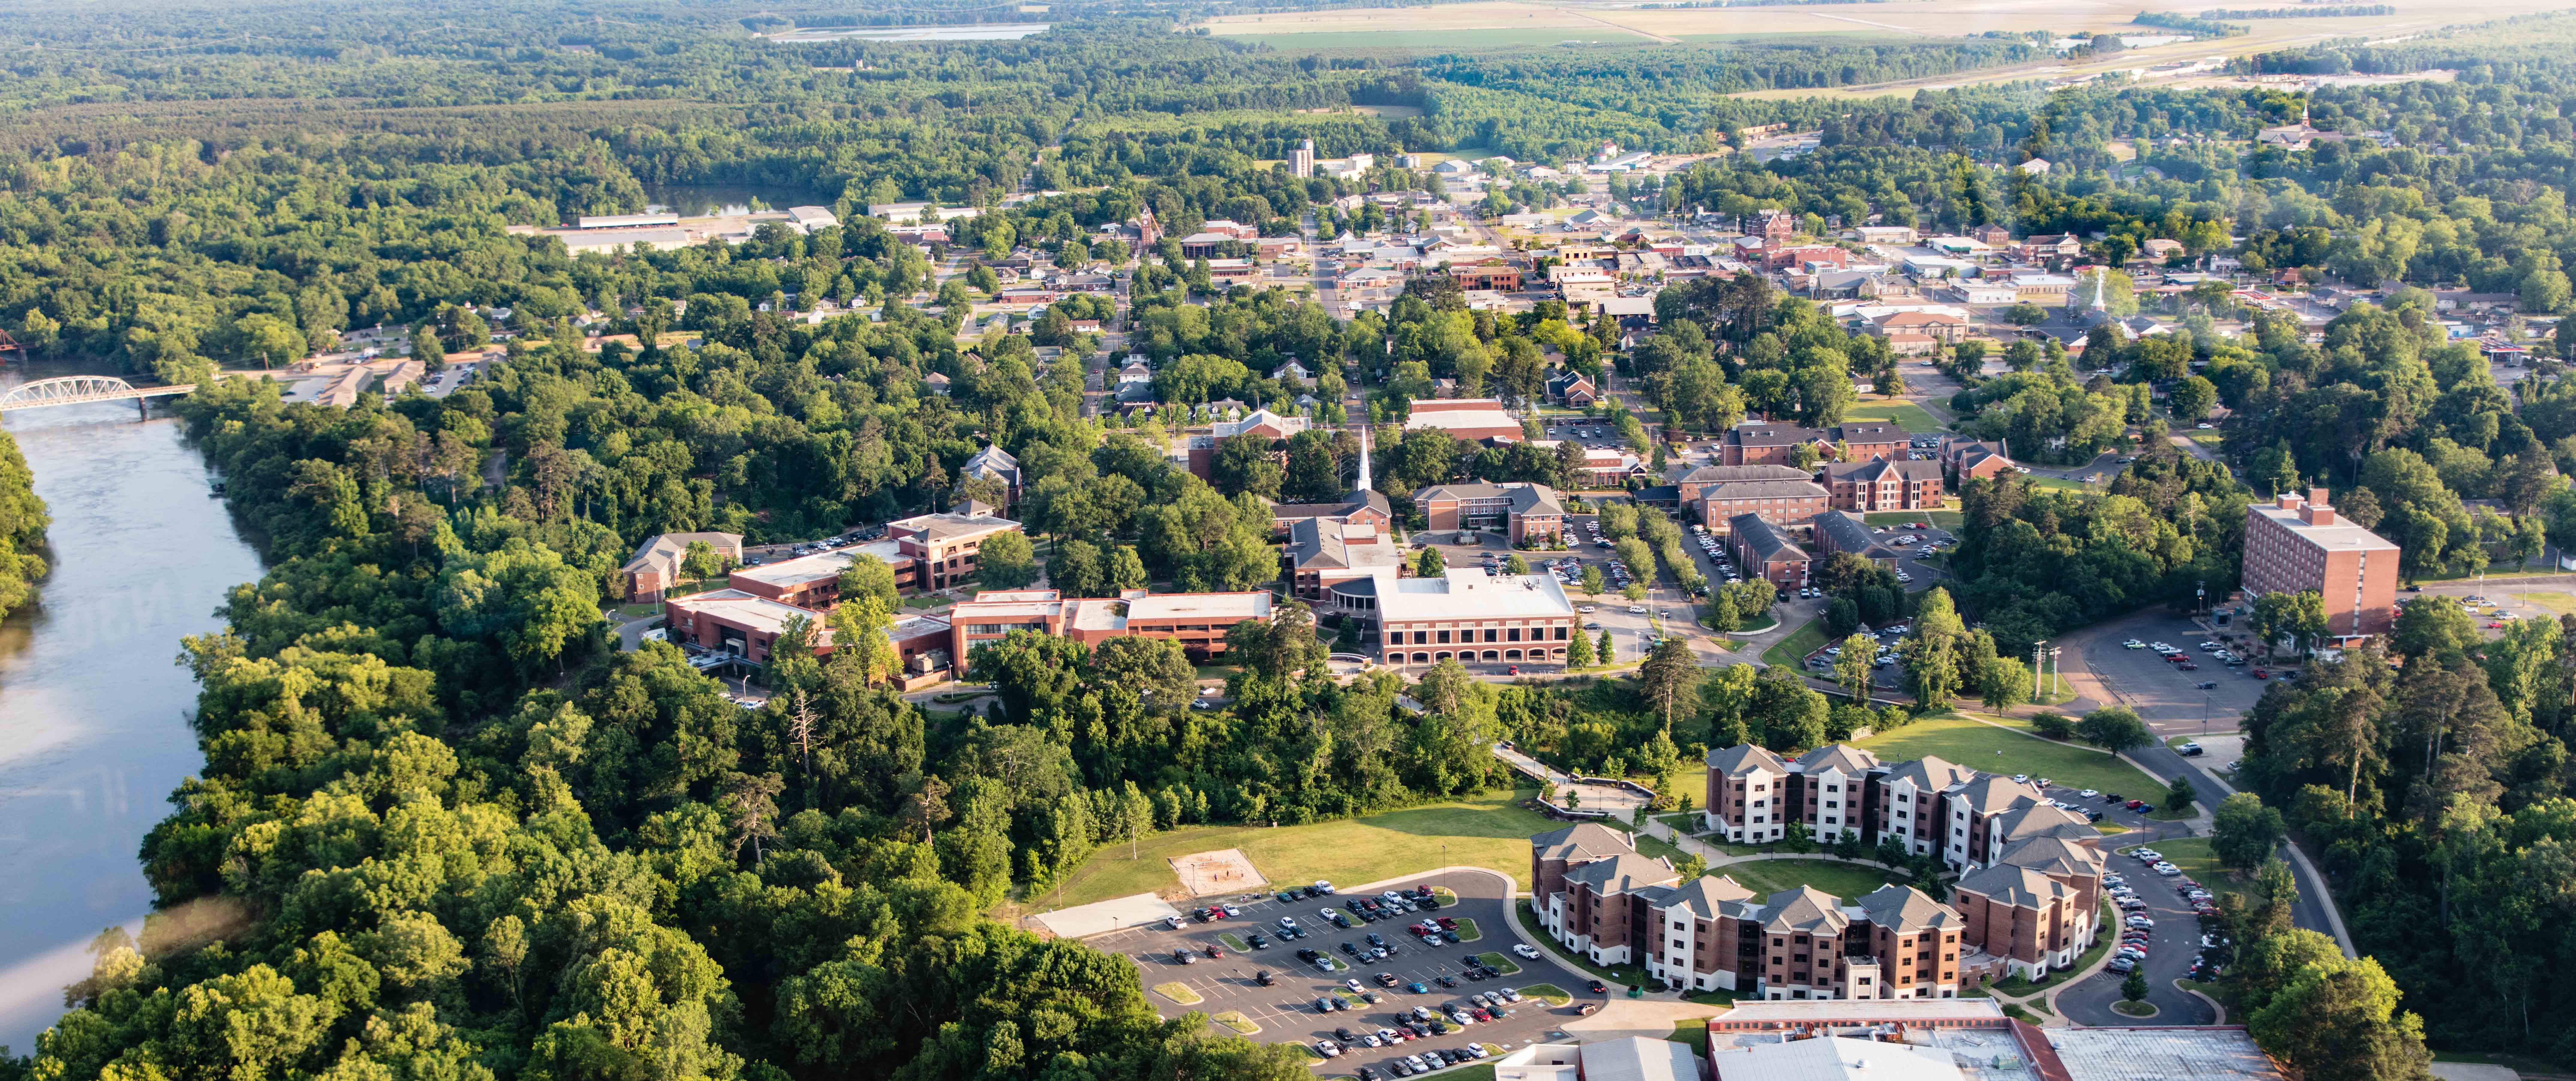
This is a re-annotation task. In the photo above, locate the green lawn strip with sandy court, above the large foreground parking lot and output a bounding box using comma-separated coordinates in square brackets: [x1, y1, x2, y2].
[1025, 790, 1558, 909]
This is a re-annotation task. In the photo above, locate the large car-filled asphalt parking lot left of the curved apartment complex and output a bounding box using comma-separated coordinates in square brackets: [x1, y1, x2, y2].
[1090, 872, 1602, 1076]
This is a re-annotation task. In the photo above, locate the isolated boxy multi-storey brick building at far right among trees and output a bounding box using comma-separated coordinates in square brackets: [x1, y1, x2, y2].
[2241, 489, 2398, 643]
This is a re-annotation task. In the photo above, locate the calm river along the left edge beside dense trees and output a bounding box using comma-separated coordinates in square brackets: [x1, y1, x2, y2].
[0, 363, 260, 1053]
